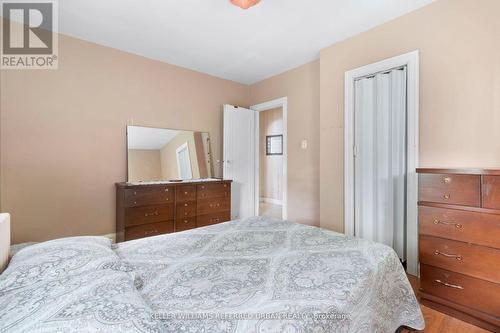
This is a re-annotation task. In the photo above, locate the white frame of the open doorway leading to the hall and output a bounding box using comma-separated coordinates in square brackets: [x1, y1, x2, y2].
[250, 97, 288, 220]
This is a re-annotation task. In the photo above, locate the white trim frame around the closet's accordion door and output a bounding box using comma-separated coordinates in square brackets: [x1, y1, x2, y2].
[344, 50, 420, 276]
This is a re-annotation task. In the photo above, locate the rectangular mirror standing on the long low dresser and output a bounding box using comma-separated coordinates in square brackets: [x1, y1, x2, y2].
[127, 126, 212, 182]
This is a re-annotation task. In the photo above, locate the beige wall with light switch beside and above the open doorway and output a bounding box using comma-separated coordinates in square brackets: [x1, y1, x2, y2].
[250, 61, 319, 225]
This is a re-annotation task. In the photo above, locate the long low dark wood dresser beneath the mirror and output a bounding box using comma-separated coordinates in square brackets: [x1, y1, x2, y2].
[116, 180, 231, 242]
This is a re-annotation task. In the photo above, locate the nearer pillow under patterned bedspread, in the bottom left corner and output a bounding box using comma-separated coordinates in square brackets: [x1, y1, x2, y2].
[0, 269, 151, 332]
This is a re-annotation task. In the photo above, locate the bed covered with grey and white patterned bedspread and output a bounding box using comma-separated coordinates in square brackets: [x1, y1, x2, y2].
[0, 217, 424, 333]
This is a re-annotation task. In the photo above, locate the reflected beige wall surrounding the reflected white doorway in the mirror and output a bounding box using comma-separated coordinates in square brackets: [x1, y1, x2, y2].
[160, 131, 200, 179]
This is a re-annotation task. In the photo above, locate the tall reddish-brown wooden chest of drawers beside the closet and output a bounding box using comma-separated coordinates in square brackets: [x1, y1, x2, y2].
[417, 169, 500, 332]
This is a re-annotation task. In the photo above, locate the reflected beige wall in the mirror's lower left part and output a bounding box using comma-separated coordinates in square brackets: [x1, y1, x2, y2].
[128, 149, 162, 182]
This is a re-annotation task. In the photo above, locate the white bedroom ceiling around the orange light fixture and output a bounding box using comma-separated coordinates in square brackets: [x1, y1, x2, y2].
[59, 0, 433, 84]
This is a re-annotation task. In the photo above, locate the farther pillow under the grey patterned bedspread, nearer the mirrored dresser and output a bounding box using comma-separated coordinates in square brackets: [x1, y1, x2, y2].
[0, 233, 119, 296]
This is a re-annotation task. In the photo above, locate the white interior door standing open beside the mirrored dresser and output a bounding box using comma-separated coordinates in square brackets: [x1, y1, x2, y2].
[223, 105, 256, 219]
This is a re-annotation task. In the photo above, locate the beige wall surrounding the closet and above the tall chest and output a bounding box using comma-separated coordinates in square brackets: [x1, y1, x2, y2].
[320, 0, 500, 231]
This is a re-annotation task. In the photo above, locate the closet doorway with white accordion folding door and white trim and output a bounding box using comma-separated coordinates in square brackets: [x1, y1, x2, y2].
[344, 51, 419, 275]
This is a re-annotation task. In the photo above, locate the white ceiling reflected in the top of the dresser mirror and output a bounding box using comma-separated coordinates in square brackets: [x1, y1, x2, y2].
[127, 126, 180, 150]
